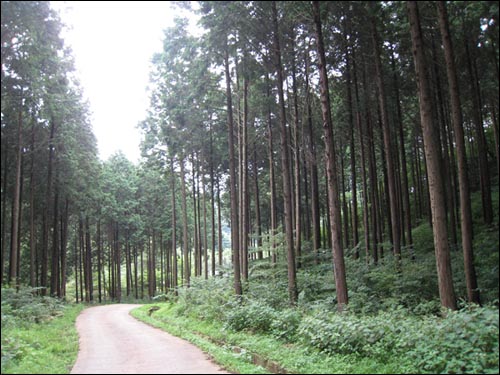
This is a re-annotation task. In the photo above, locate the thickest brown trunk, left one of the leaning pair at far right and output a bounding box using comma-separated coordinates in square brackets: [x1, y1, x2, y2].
[407, 1, 457, 310]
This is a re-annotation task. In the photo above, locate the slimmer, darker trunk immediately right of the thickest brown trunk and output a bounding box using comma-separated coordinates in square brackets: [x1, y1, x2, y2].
[437, 1, 480, 303]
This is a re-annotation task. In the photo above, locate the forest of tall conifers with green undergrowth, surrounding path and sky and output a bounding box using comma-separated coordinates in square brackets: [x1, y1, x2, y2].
[1, 1, 500, 373]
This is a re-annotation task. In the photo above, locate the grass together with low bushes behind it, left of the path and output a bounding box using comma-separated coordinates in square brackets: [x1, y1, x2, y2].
[2, 288, 85, 374]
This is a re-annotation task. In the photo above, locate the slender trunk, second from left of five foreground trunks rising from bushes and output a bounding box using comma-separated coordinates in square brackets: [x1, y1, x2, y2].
[272, 1, 297, 305]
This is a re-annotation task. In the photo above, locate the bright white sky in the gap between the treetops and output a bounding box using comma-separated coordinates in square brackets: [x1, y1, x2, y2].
[51, 1, 192, 163]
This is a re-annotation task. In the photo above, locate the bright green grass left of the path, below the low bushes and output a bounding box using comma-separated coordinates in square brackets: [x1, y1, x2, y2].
[2, 305, 85, 374]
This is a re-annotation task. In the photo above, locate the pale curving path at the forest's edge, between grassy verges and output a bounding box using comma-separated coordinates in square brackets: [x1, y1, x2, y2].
[71, 304, 226, 374]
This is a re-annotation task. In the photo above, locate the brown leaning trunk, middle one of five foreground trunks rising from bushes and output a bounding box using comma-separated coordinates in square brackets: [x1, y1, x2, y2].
[313, 1, 348, 311]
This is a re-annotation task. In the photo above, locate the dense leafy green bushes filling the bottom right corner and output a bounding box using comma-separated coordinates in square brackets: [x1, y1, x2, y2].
[298, 306, 499, 373]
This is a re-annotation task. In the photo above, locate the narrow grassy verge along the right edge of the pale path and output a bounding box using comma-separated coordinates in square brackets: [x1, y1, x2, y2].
[132, 303, 411, 374]
